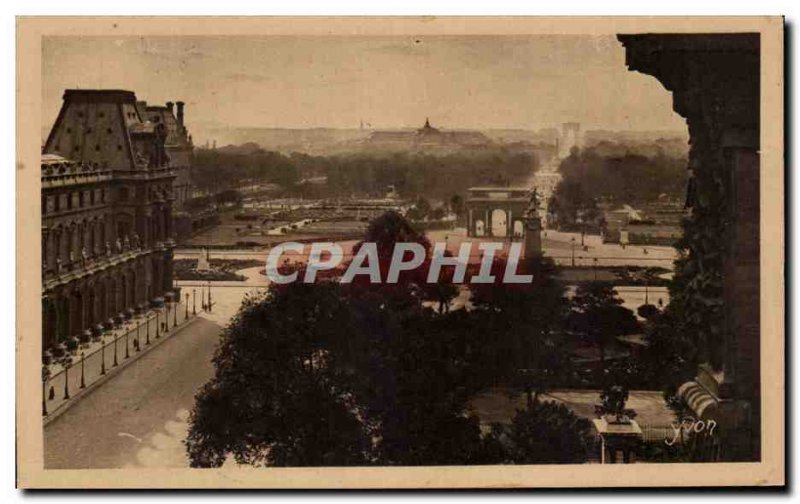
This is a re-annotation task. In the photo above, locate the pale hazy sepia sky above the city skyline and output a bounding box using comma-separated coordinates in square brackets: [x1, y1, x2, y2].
[42, 36, 686, 142]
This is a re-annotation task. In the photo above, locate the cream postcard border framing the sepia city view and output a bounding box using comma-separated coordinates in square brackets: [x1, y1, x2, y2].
[16, 17, 785, 488]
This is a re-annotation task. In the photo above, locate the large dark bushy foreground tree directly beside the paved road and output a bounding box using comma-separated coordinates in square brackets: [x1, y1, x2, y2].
[186, 283, 371, 467]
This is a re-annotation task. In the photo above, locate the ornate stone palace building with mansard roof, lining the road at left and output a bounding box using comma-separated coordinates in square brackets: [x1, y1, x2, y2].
[41, 90, 180, 349]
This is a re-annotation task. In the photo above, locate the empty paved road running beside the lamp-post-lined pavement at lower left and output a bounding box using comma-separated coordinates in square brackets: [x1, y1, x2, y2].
[44, 318, 221, 469]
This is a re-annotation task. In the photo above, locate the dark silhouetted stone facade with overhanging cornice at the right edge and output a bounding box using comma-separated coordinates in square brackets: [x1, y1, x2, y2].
[619, 33, 761, 461]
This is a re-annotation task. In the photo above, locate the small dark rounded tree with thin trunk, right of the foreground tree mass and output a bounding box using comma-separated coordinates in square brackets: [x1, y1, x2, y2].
[570, 282, 639, 369]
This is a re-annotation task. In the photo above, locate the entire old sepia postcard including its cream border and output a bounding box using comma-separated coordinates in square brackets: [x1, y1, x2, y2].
[16, 17, 785, 488]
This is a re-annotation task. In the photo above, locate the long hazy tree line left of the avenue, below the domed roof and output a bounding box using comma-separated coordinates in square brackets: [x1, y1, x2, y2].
[192, 147, 539, 199]
